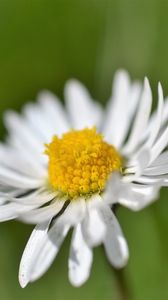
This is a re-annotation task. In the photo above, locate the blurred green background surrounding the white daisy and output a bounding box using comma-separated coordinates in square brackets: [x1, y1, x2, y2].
[0, 0, 168, 300]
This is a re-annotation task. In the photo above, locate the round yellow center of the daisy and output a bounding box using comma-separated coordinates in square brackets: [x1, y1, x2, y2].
[45, 128, 122, 199]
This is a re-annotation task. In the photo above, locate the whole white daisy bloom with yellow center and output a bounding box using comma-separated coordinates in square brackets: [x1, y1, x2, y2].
[0, 71, 168, 287]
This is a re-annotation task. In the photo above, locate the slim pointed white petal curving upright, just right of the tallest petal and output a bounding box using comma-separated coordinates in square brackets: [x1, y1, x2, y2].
[123, 78, 152, 154]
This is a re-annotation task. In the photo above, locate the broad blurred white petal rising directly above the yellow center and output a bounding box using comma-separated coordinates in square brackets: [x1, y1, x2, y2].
[65, 80, 102, 129]
